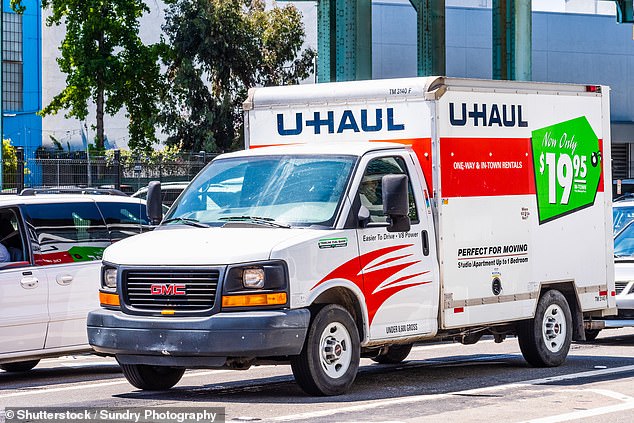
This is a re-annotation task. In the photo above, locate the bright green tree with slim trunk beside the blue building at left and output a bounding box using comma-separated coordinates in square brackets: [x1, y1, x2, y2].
[36, 0, 163, 151]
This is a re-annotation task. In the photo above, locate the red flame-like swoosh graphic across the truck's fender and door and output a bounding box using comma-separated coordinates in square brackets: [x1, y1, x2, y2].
[311, 244, 431, 325]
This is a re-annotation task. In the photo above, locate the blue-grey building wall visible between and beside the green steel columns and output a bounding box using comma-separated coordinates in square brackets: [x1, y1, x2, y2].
[373, 1, 634, 122]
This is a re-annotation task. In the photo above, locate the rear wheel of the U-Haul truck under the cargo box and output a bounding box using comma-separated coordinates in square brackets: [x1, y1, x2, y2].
[517, 290, 572, 367]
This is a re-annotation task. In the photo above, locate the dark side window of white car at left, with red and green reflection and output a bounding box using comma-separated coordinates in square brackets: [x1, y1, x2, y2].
[24, 202, 110, 266]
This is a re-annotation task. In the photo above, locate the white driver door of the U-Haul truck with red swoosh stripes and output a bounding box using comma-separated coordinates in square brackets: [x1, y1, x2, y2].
[355, 154, 438, 340]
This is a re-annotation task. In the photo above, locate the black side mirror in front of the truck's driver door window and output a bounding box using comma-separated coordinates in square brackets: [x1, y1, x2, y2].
[381, 175, 410, 232]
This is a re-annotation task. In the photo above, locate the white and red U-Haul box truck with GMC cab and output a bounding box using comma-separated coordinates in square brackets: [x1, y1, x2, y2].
[88, 77, 615, 395]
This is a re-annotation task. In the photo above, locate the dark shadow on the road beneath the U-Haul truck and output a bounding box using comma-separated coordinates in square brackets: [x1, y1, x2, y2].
[115, 354, 634, 406]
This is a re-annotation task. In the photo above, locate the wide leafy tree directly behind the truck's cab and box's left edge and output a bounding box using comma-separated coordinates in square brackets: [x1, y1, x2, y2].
[161, 0, 316, 151]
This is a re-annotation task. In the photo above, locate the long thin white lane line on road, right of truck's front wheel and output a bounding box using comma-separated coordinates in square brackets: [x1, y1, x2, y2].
[271, 366, 634, 422]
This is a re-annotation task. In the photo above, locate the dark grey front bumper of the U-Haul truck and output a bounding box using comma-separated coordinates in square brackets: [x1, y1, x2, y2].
[88, 309, 310, 367]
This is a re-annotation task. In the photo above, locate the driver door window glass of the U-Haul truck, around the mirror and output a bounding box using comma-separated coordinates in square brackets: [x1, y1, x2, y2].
[359, 157, 418, 223]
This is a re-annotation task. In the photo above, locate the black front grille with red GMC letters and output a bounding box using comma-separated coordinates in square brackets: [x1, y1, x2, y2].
[123, 269, 220, 312]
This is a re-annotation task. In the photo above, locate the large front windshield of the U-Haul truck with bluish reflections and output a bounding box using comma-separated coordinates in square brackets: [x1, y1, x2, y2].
[164, 155, 356, 226]
